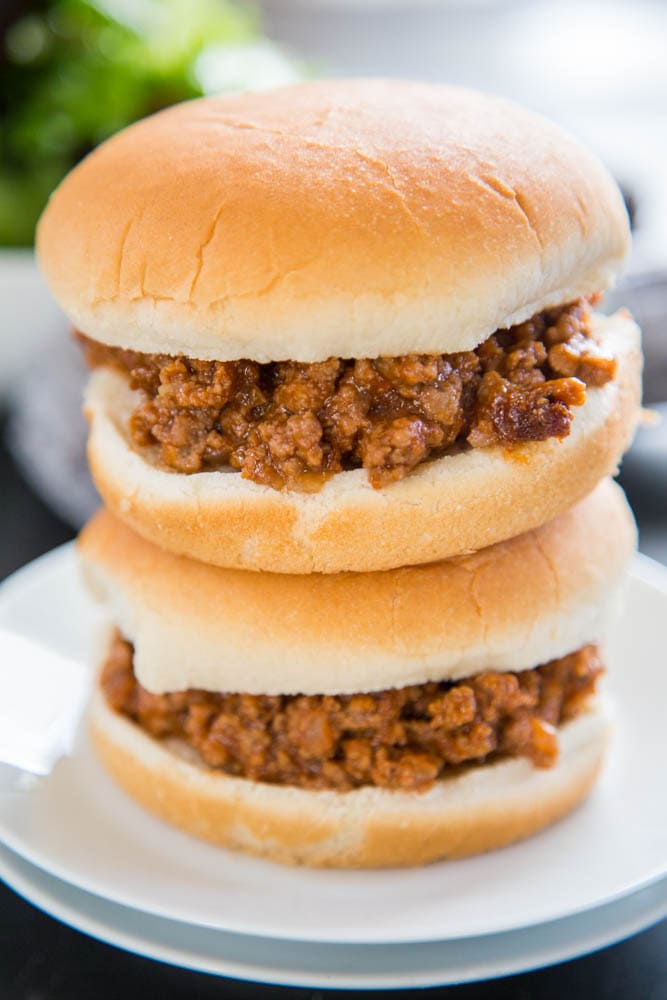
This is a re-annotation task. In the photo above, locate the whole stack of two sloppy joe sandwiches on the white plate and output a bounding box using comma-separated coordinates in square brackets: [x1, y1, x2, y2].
[38, 81, 641, 866]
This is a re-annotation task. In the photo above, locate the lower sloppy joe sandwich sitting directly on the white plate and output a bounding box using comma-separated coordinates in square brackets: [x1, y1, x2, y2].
[79, 481, 635, 867]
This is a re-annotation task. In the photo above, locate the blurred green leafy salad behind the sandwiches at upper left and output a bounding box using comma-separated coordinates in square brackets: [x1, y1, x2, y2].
[0, 0, 284, 246]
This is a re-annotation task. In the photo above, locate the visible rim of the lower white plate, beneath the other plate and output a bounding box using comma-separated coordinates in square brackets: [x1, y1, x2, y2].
[0, 848, 667, 989]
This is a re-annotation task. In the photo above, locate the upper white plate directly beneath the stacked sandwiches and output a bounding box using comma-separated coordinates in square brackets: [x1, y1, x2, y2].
[0, 547, 667, 943]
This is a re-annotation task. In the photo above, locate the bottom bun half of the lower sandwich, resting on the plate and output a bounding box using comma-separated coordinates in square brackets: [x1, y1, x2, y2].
[90, 692, 610, 868]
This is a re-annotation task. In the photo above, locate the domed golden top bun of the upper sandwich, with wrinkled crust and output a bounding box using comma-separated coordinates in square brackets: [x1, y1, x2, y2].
[37, 80, 628, 362]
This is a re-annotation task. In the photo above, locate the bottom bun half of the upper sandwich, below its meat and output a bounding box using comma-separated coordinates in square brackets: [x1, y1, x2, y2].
[86, 313, 641, 573]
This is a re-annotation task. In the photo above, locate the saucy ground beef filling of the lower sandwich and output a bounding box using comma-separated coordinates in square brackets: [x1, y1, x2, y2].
[101, 633, 602, 791]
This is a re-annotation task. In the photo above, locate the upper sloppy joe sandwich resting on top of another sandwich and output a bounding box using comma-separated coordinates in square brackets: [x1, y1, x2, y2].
[37, 80, 640, 572]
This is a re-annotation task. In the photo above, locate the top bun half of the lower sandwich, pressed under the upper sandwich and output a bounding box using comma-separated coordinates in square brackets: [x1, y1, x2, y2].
[78, 480, 636, 695]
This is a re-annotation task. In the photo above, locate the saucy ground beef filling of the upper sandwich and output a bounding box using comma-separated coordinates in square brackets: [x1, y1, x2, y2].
[81, 300, 615, 490]
